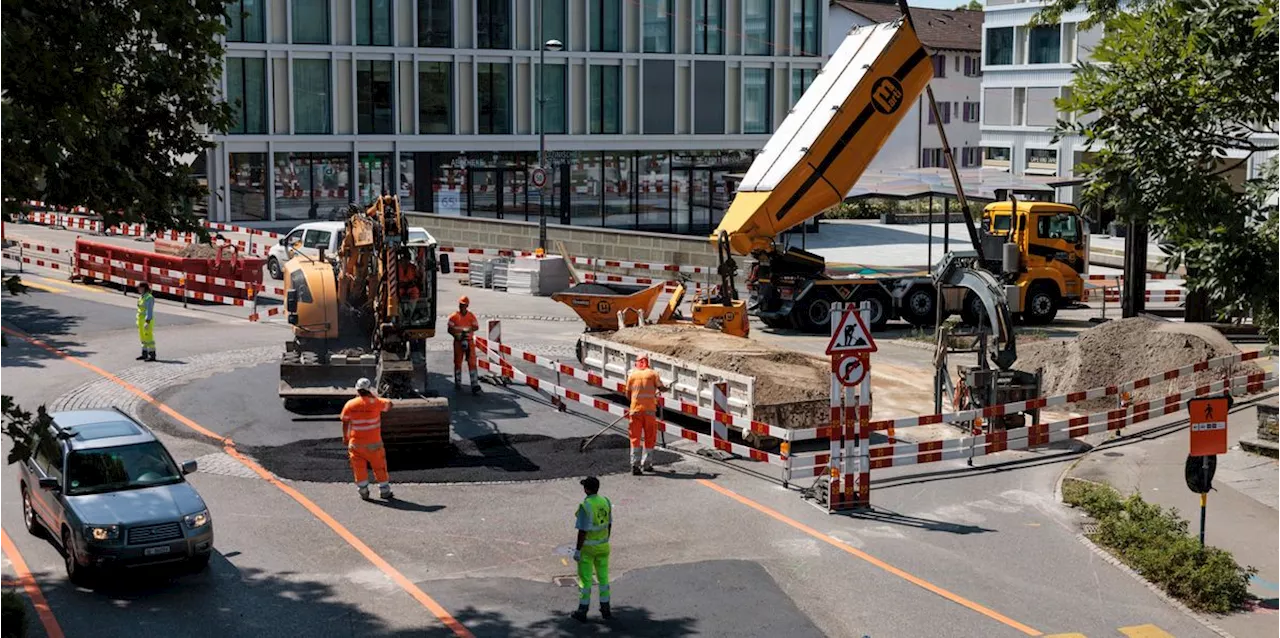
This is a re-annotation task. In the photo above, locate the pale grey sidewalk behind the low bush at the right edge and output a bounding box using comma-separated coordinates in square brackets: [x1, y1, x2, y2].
[1070, 406, 1280, 638]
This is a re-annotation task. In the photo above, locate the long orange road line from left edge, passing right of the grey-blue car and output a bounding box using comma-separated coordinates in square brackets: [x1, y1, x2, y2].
[0, 325, 475, 638]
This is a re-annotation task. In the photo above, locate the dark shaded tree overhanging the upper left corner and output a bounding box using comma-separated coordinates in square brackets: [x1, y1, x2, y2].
[0, 0, 232, 462]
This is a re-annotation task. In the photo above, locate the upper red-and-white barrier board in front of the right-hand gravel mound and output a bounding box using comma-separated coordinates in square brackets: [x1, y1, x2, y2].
[791, 351, 1262, 441]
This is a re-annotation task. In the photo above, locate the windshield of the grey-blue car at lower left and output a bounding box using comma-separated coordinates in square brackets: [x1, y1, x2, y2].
[67, 441, 182, 496]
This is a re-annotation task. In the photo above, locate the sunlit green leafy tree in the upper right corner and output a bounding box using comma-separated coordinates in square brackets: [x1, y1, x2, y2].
[1036, 0, 1280, 342]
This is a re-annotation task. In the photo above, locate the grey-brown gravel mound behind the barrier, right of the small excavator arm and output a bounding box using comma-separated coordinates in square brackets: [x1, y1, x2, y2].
[1014, 316, 1258, 413]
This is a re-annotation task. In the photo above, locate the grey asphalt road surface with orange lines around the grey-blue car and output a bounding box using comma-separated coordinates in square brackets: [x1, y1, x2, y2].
[0, 276, 1213, 638]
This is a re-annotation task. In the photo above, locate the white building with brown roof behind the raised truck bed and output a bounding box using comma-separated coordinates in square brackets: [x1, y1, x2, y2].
[827, 0, 983, 173]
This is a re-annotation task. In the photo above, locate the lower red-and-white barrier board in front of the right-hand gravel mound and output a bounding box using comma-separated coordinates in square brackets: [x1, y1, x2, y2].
[791, 373, 1280, 477]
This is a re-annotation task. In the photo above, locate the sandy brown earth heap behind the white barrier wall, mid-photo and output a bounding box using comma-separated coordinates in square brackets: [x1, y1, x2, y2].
[600, 324, 831, 428]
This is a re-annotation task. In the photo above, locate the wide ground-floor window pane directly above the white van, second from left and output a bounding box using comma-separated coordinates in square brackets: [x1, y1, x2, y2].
[275, 152, 351, 219]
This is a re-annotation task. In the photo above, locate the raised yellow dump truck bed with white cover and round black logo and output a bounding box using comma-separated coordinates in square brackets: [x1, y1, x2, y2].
[712, 19, 933, 255]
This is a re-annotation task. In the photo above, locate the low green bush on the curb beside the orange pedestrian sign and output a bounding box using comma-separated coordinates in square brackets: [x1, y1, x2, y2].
[1062, 479, 1257, 614]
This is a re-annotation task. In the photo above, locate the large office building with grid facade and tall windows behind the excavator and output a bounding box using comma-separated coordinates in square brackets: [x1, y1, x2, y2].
[206, 0, 827, 233]
